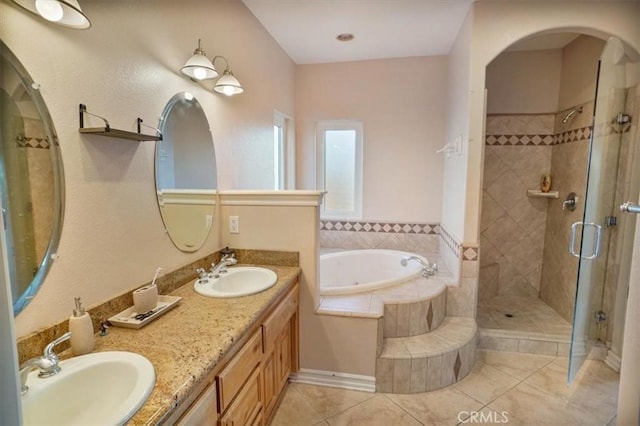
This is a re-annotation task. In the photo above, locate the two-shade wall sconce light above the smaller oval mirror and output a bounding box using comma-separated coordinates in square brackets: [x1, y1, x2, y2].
[180, 39, 244, 96]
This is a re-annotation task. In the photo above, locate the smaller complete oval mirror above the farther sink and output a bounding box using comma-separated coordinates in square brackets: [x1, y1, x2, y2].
[156, 92, 217, 252]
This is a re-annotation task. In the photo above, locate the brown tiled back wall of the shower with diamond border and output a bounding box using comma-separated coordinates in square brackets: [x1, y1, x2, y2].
[478, 114, 557, 300]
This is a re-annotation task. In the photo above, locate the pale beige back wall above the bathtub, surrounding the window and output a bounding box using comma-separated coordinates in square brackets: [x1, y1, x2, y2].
[296, 56, 447, 223]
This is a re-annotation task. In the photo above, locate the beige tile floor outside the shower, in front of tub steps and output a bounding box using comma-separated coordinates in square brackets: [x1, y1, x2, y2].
[271, 351, 619, 426]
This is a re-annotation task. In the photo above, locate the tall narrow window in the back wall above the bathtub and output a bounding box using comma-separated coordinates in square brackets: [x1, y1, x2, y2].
[316, 121, 363, 219]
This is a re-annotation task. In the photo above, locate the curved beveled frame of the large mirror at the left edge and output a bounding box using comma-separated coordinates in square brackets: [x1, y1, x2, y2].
[0, 40, 64, 316]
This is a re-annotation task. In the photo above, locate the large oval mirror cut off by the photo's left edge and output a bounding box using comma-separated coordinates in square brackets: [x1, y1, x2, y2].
[0, 41, 64, 315]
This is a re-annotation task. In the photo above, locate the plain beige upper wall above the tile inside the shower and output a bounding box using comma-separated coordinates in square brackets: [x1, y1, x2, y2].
[486, 49, 562, 114]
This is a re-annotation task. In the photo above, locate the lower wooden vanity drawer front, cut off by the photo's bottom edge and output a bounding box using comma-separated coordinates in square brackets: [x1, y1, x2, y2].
[220, 368, 262, 426]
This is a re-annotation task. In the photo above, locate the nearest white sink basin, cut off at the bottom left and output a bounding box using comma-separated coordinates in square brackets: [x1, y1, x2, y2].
[22, 352, 156, 425]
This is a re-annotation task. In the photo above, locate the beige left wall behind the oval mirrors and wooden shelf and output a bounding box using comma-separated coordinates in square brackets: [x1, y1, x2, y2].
[0, 0, 295, 336]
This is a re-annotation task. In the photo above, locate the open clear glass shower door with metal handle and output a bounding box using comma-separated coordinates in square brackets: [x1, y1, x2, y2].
[568, 38, 626, 383]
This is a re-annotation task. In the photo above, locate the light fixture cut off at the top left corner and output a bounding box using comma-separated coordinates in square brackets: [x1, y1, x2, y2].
[12, 0, 91, 30]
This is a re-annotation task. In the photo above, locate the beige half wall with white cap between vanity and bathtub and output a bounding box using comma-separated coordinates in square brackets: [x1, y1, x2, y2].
[220, 191, 378, 376]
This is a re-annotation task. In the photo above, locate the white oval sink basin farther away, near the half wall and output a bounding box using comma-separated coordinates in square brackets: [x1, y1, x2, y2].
[193, 266, 278, 297]
